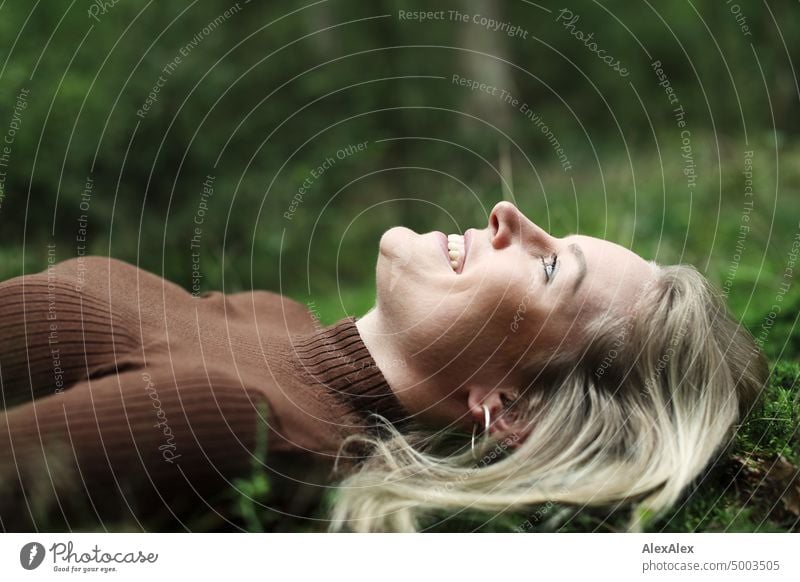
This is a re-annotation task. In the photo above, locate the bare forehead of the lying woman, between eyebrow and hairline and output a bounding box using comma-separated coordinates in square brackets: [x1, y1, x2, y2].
[562, 235, 656, 309]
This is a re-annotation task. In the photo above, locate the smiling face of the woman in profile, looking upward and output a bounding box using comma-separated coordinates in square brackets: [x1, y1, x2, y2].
[377, 202, 655, 389]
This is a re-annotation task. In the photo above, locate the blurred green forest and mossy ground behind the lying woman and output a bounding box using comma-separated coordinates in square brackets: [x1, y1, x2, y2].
[0, 0, 800, 531]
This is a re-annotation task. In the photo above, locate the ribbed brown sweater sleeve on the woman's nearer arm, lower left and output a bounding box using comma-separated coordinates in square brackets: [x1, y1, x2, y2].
[0, 364, 269, 530]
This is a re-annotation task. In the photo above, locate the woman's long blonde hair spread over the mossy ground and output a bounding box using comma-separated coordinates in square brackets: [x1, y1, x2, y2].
[330, 265, 766, 532]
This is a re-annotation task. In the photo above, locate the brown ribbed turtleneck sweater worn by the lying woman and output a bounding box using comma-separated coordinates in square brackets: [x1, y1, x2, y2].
[0, 257, 405, 530]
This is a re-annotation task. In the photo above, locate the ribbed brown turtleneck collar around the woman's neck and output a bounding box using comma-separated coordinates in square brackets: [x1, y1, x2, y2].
[293, 317, 409, 428]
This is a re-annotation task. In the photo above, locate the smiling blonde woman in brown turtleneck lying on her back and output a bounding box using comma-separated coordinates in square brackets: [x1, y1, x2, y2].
[0, 202, 765, 531]
